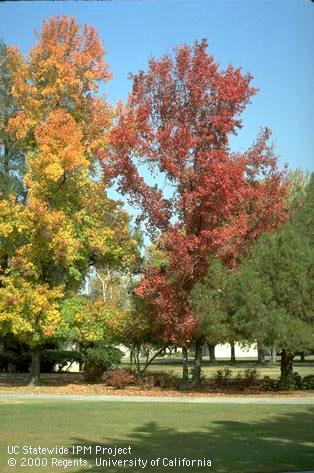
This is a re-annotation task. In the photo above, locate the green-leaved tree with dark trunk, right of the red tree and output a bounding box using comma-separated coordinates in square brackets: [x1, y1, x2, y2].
[228, 176, 314, 386]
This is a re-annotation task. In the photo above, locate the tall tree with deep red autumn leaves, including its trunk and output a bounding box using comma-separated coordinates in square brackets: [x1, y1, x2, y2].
[99, 40, 286, 380]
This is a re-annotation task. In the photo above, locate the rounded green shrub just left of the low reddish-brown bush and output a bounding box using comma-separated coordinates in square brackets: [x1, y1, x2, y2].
[84, 345, 123, 382]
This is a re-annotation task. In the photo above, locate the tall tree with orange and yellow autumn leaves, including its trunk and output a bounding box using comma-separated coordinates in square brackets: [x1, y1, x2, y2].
[0, 17, 135, 382]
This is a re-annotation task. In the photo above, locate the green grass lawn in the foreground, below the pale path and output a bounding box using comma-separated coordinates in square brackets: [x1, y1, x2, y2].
[0, 401, 314, 473]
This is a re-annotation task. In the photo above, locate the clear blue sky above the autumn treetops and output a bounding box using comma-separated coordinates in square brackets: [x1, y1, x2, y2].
[0, 0, 314, 175]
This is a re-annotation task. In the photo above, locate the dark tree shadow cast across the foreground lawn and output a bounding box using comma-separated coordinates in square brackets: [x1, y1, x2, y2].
[68, 407, 314, 473]
